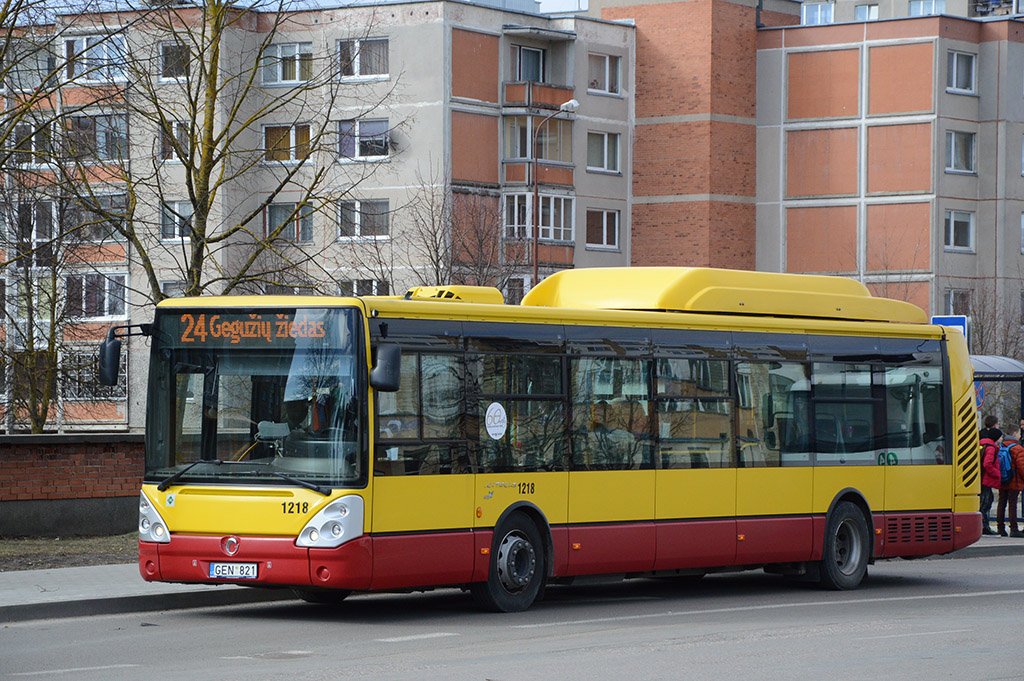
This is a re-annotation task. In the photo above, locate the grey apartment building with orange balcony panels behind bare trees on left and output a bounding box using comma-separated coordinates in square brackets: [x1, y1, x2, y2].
[5, 0, 635, 430]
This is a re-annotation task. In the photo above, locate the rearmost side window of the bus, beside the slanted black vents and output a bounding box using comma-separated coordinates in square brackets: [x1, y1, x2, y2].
[884, 365, 947, 466]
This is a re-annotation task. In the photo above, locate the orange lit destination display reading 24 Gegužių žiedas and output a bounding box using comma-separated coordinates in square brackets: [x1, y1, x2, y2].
[169, 310, 327, 347]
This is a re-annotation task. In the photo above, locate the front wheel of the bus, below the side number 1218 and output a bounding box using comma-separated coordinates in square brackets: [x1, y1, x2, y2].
[470, 513, 545, 612]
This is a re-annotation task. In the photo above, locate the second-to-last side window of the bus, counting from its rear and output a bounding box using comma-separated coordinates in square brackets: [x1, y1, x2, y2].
[813, 363, 879, 466]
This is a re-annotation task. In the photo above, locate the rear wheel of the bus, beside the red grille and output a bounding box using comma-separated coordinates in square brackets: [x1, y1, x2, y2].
[820, 502, 871, 591]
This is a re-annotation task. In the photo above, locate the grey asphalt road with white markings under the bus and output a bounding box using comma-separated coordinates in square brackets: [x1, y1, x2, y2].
[0, 556, 1024, 681]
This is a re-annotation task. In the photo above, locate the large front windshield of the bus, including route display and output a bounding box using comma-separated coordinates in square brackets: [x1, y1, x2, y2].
[145, 308, 367, 487]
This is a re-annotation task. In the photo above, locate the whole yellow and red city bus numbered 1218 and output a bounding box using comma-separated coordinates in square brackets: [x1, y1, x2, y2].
[101, 268, 981, 611]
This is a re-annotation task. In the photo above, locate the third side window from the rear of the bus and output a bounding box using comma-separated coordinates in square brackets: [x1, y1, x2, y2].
[736, 361, 810, 468]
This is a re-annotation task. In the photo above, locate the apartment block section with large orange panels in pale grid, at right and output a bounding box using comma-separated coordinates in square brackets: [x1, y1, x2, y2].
[757, 16, 1024, 323]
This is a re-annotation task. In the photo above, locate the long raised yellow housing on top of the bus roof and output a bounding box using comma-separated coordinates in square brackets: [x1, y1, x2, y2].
[522, 267, 928, 324]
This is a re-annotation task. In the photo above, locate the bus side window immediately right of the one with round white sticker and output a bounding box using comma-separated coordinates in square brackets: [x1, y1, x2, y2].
[569, 357, 651, 470]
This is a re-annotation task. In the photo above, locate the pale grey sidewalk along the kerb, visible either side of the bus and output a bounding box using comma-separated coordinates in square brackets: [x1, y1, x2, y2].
[0, 537, 1024, 625]
